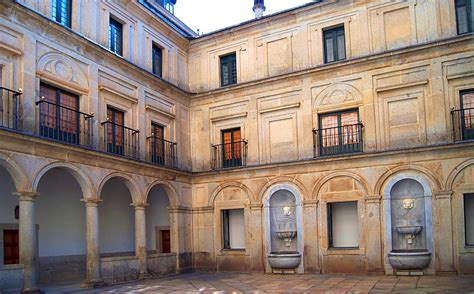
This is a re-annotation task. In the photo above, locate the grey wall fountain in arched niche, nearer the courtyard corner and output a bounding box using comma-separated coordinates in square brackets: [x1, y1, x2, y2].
[265, 190, 301, 273]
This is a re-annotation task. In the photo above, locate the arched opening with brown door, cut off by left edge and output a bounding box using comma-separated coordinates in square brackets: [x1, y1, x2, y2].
[0, 165, 20, 266]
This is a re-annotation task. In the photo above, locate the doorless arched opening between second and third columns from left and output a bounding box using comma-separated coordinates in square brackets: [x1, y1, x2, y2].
[99, 177, 135, 257]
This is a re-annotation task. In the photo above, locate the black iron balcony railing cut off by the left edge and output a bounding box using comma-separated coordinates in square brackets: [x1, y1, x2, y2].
[0, 87, 22, 130]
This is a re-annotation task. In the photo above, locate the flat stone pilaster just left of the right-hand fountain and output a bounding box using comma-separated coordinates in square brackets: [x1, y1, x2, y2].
[364, 195, 383, 272]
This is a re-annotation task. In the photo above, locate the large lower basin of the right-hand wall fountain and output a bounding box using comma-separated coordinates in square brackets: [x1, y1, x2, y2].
[388, 249, 431, 270]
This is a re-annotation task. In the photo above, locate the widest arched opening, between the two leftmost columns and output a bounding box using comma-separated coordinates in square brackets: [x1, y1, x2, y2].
[35, 167, 86, 284]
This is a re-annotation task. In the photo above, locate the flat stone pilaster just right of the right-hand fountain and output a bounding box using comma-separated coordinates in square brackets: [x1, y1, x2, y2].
[434, 191, 455, 272]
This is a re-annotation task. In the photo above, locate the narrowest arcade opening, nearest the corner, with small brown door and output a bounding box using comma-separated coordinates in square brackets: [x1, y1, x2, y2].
[146, 185, 172, 253]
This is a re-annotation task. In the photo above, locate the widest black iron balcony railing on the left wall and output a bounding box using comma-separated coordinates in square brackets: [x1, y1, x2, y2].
[36, 98, 94, 148]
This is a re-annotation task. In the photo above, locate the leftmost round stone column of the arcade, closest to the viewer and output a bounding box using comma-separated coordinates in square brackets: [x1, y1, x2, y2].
[14, 191, 40, 293]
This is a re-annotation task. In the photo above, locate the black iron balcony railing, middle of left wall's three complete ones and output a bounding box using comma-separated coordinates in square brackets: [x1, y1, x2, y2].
[101, 120, 140, 158]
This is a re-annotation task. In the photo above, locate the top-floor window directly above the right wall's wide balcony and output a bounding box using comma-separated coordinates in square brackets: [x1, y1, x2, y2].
[323, 26, 346, 63]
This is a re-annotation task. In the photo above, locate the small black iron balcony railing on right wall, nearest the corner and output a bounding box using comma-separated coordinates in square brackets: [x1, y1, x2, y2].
[212, 140, 247, 169]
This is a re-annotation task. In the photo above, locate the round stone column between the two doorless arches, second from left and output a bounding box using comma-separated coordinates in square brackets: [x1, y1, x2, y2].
[82, 199, 103, 288]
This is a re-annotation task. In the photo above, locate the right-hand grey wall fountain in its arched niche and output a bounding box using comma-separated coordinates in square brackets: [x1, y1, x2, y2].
[388, 179, 431, 274]
